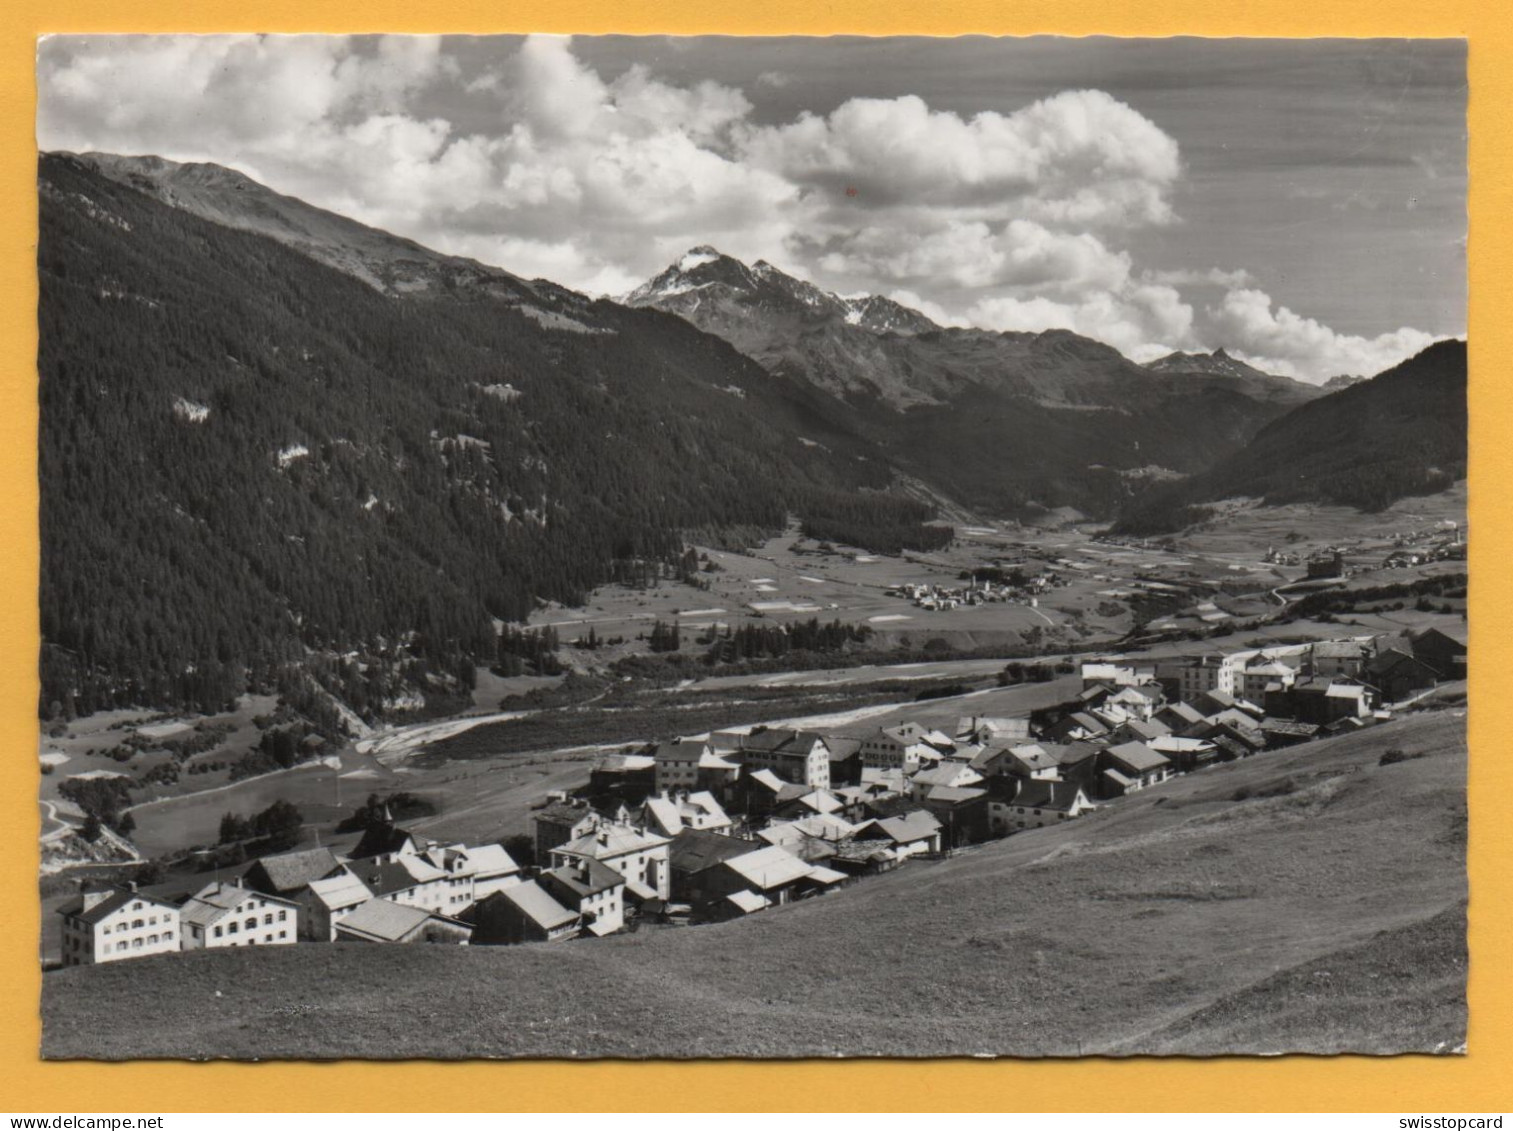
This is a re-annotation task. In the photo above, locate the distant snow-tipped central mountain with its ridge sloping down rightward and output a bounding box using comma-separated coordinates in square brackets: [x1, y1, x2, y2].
[625, 246, 1319, 517]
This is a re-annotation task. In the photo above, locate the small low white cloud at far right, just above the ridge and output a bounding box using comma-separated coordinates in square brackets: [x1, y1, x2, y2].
[1207, 289, 1434, 383]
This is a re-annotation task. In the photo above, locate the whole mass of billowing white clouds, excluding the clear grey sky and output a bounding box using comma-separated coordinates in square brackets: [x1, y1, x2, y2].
[38, 36, 1428, 370]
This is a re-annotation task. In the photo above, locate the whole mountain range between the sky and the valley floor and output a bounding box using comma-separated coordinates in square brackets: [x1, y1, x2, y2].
[38, 153, 1465, 715]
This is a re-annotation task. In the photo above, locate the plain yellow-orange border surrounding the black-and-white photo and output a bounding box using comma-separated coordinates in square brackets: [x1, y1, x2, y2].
[0, 0, 1513, 1113]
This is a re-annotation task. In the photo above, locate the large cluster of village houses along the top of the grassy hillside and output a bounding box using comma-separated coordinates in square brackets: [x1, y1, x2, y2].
[59, 624, 1466, 966]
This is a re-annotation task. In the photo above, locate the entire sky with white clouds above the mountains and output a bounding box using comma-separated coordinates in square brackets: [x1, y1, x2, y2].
[38, 36, 1466, 380]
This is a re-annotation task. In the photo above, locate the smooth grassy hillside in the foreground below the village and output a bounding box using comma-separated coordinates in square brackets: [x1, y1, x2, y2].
[42, 711, 1466, 1058]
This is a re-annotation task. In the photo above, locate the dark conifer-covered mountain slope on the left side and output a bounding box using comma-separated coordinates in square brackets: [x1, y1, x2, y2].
[39, 156, 938, 711]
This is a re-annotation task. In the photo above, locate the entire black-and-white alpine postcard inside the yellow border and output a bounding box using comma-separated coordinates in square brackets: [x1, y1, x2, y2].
[38, 35, 1469, 1060]
